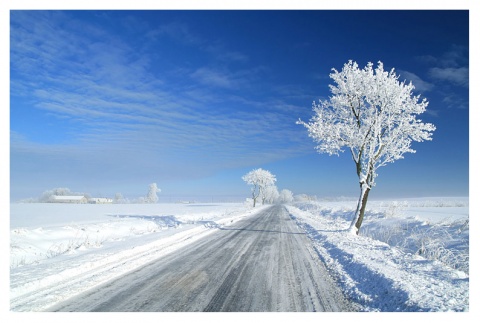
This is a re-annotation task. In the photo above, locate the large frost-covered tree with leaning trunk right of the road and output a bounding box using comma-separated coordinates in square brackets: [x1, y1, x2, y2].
[297, 61, 435, 234]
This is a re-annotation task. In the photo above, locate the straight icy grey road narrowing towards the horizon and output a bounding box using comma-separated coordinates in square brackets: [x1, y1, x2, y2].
[48, 205, 354, 312]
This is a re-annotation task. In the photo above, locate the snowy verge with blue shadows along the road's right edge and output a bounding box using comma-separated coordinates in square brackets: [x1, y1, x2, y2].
[287, 203, 469, 312]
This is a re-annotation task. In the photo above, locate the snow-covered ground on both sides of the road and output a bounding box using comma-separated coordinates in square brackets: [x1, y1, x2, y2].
[10, 198, 470, 312]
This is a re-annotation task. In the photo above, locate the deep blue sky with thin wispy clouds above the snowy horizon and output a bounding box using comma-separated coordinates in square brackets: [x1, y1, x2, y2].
[10, 10, 470, 200]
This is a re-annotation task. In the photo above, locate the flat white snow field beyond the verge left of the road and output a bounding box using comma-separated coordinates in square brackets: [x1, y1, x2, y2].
[10, 203, 253, 268]
